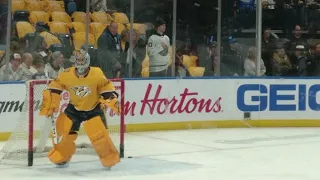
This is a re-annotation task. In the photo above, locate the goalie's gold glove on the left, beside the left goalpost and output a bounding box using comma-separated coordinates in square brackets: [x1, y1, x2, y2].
[40, 90, 60, 117]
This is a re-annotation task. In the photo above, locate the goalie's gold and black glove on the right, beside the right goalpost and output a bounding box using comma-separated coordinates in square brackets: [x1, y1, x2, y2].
[100, 92, 121, 115]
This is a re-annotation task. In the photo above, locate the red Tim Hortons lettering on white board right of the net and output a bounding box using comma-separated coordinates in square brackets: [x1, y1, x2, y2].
[124, 83, 222, 116]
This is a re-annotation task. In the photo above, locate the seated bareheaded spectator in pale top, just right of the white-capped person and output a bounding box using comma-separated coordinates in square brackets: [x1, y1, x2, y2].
[19, 53, 37, 79]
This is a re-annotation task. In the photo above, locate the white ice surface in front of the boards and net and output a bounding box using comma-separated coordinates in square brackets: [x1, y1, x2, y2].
[0, 128, 320, 180]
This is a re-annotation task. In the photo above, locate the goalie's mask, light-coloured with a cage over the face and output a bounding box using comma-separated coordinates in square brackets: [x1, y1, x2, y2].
[74, 49, 90, 75]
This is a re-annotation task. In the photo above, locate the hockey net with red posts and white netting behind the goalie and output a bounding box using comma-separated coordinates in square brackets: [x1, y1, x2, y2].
[0, 79, 125, 166]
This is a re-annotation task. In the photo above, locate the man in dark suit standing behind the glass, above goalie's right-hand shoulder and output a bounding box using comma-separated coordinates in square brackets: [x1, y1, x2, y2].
[98, 22, 125, 78]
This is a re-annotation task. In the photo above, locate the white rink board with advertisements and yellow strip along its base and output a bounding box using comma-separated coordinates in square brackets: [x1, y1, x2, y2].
[0, 78, 320, 140]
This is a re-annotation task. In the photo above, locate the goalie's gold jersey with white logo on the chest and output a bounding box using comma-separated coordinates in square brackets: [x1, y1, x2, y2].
[49, 67, 115, 111]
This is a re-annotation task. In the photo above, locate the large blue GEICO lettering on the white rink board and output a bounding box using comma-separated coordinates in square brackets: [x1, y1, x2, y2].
[237, 84, 320, 112]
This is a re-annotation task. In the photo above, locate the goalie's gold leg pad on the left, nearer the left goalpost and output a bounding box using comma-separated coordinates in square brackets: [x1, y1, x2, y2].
[48, 113, 78, 164]
